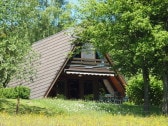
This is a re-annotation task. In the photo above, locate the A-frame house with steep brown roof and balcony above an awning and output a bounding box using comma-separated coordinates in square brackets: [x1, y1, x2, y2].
[9, 31, 125, 100]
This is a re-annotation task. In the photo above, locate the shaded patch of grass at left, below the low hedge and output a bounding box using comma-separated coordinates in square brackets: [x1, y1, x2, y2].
[0, 99, 64, 116]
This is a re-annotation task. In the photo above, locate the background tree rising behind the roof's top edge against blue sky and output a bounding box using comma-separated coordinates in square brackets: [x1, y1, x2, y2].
[29, 0, 73, 42]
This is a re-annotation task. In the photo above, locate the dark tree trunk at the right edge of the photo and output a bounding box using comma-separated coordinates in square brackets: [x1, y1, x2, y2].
[162, 62, 168, 115]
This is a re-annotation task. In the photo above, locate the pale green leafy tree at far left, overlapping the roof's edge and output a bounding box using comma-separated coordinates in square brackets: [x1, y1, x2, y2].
[0, 0, 37, 87]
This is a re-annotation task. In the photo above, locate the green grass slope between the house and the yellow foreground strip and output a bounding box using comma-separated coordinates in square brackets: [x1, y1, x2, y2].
[0, 99, 161, 116]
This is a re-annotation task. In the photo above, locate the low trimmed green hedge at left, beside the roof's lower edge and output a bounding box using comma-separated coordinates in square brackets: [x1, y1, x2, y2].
[0, 86, 30, 99]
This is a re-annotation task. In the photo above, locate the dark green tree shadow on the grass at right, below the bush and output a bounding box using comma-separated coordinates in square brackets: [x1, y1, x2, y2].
[96, 103, 162, 116]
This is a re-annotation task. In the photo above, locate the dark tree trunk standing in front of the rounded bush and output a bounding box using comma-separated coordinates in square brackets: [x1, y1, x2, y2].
[142, 66, 150, 115]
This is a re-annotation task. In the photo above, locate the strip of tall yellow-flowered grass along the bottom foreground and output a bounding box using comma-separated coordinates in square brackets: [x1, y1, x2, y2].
[0, 113, 168, 126]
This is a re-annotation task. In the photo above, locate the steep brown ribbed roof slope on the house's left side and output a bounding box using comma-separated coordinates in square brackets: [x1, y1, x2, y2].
[10, 31, 72, 98]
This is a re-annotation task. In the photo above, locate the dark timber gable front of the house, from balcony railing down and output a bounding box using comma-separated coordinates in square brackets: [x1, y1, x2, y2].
[45, 43, 125, 99]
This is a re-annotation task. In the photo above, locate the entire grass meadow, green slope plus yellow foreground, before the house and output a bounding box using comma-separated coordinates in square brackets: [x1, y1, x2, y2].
[0, 99, 168, 126]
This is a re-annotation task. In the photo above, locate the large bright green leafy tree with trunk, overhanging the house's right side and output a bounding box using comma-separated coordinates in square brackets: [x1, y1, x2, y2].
[74, 0, 168, 112]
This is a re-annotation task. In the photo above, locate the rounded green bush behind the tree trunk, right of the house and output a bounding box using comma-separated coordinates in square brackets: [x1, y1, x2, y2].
[126, 74, 163, 106]
